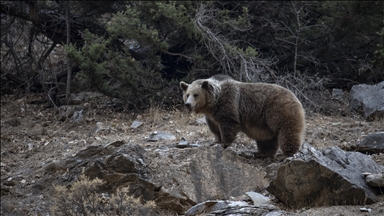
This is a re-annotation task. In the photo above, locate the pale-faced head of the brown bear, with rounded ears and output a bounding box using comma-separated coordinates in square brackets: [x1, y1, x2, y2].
[180, 80, 214, 114]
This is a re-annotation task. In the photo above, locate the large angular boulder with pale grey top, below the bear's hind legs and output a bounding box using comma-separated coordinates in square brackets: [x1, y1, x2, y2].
[267, 143, 384, 208]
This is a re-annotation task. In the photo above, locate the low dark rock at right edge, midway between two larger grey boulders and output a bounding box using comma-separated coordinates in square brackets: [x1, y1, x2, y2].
[356, 132, 384, 154]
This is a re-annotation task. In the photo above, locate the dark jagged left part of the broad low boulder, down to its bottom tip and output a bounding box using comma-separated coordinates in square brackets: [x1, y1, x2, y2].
[55, 141, 195, 213]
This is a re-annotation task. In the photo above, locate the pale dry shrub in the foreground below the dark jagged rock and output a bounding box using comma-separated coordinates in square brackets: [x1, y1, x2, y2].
[51, 175, 158, 215]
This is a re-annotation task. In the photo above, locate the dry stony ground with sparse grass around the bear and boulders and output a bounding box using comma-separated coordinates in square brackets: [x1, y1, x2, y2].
[1, 94, 384, 215]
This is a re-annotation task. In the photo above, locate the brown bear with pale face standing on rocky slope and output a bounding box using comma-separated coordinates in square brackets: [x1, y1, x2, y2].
[180, 75, 305, 157]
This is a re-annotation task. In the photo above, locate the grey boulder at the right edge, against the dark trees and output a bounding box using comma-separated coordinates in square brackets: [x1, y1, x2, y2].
[350, 81, 384, 118]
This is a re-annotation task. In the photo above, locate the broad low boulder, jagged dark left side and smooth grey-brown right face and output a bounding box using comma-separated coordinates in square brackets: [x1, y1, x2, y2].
[51, 141, 268, 214]
